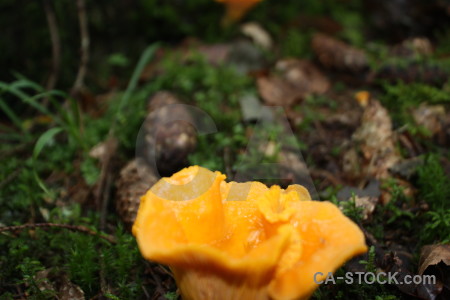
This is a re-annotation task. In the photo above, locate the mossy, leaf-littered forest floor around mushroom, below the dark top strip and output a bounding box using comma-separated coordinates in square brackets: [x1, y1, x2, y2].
[0, 1, 450, 300]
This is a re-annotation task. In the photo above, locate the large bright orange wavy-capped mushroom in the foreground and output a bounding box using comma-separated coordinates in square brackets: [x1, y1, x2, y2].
[133, 166, 367, 300]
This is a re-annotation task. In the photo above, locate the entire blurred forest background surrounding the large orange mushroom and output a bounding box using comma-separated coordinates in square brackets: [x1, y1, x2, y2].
[0, 0, 450, 300]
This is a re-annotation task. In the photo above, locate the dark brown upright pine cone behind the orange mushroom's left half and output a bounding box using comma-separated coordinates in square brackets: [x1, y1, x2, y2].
[141, 91, 197, 176]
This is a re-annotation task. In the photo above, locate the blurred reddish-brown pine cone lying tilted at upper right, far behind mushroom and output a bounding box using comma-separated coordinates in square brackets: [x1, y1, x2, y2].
[312, 33, 368, 73]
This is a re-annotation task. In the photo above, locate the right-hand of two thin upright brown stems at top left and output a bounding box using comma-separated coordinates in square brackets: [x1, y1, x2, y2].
[71, 0, 89, 96]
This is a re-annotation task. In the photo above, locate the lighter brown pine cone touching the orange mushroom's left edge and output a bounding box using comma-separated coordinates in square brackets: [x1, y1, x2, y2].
[116, 159, 158, 229]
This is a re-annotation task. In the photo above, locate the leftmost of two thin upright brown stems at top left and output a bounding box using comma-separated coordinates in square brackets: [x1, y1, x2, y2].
[43, 0, 61, 95]
